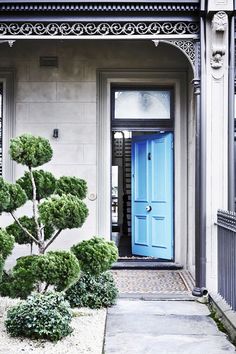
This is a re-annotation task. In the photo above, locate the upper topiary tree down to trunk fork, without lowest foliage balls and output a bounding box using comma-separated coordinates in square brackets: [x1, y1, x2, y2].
[0, 134, 88, 254]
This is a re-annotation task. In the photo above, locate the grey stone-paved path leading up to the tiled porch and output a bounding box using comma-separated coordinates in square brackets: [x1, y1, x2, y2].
[104, 299, 235, 354]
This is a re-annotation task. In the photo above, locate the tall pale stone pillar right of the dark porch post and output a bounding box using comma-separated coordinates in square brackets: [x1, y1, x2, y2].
[205, 7, 233, 291]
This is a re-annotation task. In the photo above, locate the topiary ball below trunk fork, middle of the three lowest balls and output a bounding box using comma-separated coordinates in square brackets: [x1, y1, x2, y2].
[35, 251, 80, 291]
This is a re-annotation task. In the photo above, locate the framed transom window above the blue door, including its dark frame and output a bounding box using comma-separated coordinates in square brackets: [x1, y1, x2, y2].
[111, 86, 173, 127]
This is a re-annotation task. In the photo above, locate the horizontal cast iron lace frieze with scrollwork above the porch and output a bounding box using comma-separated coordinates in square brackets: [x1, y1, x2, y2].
[0, 22, 199, 37]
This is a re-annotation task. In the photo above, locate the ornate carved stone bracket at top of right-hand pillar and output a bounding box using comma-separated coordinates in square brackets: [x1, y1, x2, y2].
[211, 11, 228, 69]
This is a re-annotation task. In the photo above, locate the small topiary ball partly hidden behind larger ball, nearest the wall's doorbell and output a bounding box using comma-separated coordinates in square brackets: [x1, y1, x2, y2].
[56, 176, 87, 199]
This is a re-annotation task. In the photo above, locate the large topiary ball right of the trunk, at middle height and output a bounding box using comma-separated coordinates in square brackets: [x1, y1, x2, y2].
[39, 194, 88, 230]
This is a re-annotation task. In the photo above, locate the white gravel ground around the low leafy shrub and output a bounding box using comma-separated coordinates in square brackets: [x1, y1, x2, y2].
[0, 297, 106, 354]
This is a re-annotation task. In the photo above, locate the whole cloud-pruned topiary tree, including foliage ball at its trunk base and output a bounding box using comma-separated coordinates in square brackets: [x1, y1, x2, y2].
[0, 134, 88, 297]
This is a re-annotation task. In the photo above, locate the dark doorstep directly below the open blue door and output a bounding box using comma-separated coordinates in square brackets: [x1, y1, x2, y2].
[112, 259, 183, 270]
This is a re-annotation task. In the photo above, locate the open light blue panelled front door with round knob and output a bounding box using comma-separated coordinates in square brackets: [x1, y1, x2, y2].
[132, 133, 173, 260]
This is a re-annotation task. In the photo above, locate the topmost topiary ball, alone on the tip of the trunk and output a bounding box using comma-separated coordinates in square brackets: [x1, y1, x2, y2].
[10, 134, 53, 167]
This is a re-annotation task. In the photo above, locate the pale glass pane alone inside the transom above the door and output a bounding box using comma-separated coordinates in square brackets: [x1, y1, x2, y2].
[115, 90, 171, 119]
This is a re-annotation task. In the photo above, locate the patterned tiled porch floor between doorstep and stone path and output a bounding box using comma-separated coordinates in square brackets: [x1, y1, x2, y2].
[112, 269, 193, 294]
